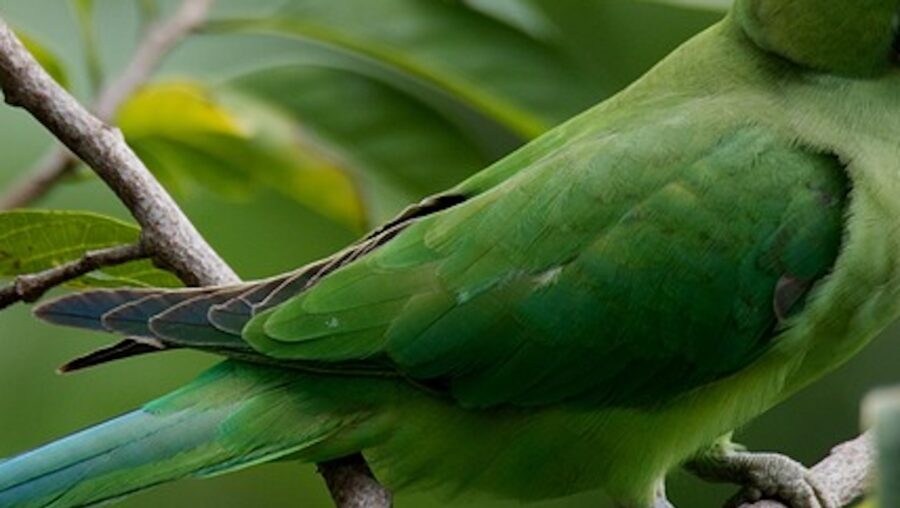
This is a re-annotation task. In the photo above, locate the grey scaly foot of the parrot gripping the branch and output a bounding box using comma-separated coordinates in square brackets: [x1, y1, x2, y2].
[685, 439, 840, 508]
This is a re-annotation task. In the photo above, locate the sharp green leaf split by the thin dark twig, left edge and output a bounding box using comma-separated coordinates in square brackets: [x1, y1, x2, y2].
[0, 210, 180, 287]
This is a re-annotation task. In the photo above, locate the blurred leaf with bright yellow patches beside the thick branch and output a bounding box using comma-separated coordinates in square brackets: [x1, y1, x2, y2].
[118, 82, 365, 230]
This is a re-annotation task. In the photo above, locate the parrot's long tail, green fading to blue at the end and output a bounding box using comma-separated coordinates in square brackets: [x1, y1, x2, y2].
[0, 361, 370, 508]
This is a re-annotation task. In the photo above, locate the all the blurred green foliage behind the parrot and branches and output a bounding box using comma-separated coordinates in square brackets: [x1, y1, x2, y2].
[0, 0, 888, 508]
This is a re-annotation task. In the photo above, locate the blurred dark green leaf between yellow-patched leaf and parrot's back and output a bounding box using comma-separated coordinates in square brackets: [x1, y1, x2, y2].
[232, 67, 493, 223]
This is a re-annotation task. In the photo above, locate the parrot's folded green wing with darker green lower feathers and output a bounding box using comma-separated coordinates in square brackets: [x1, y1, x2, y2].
[244, 126, 849, 406]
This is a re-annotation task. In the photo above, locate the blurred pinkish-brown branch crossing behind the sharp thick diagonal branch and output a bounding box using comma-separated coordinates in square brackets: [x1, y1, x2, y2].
[0, 0, 215, 210]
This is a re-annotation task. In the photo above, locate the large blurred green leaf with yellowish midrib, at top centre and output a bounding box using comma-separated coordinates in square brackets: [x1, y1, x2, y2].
[217, 0, 598, 140]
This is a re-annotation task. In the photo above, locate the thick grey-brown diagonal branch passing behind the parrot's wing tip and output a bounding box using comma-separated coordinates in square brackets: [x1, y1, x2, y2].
[0, 11, 391, 508]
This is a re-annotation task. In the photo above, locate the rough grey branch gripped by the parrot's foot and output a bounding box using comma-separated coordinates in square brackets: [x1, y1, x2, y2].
[740, 432, 876, 508]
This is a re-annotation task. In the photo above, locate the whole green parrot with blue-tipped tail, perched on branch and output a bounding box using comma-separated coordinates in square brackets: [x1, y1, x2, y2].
[0, 0, 900, 508]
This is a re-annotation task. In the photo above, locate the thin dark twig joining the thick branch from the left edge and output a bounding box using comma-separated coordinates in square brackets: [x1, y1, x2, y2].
[0, 243, 147, 309]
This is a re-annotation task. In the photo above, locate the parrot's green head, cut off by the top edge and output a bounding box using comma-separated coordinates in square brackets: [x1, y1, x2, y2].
[733, 0, 900, 76]
